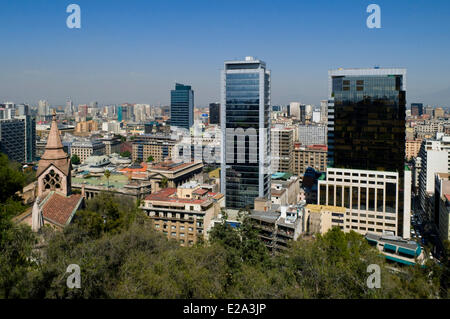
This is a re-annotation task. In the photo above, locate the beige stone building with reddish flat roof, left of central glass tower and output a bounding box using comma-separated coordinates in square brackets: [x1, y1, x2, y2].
[140, 182, 224, 246]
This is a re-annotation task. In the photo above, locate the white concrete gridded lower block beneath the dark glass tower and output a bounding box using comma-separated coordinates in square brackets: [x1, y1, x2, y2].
[318, 168, 411, 238]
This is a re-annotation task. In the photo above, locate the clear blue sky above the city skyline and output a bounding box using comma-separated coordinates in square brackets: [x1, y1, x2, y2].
[0, 0, 450, 106]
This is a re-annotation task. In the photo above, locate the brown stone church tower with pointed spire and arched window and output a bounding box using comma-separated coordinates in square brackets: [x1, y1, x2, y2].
[36, 111, 72, 198]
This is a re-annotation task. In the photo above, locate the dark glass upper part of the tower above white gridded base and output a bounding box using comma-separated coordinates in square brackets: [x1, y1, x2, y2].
[328, 68, 406, 173]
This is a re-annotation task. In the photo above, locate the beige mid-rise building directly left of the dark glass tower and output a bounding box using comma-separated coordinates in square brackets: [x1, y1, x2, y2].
[293, 143, 327, 176]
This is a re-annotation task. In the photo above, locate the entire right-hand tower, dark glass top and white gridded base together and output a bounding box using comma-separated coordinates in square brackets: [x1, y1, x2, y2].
[318, 68, 411, 238]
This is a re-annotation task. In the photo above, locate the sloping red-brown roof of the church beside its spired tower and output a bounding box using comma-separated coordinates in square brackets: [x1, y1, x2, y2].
[42, 193, 82, 226]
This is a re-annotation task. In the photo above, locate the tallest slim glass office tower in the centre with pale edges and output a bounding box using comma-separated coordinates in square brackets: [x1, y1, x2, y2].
[220, 57, 271, 209]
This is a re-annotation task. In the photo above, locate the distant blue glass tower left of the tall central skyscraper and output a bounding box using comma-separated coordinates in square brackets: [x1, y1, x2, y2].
[170, 83, 194, 130]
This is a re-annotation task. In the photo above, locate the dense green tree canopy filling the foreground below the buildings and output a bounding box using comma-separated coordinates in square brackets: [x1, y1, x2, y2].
[0, 153, 449, 298]
